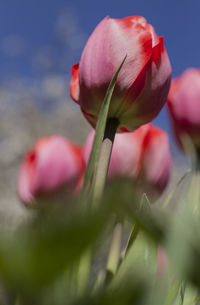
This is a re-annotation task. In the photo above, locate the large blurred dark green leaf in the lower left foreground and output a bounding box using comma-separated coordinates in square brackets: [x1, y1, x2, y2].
[0, 205, 108, 294]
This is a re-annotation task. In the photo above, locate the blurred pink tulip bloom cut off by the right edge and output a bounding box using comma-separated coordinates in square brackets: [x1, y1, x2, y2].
[167, 68, 200, 149]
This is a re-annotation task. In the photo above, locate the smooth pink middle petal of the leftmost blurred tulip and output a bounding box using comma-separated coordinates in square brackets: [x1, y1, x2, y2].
[33, 136, 79, 193]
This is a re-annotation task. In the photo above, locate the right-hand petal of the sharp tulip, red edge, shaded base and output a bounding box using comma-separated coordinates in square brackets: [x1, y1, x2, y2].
[121, 37, 171, 130]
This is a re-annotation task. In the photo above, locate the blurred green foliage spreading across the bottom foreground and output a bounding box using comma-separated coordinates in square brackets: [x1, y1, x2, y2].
[0, 179, 200, 305]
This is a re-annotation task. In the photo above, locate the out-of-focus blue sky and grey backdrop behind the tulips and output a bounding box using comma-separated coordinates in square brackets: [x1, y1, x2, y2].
[0, 0, 200, 221]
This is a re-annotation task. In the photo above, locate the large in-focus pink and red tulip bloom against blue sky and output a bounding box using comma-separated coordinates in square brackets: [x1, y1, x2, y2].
[70, 16, 171, 132]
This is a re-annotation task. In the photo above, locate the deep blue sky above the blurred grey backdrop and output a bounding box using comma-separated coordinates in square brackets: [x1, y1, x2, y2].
[0, 0, 200, 135]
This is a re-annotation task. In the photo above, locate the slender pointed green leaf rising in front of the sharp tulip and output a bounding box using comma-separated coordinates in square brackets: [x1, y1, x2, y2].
[81, 56, 127, 202]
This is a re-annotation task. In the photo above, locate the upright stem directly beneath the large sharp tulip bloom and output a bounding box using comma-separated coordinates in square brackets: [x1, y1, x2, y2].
[90, 118, 119, 204]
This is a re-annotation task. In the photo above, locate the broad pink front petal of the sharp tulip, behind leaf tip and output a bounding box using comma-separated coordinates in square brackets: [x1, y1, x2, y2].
[79, 17, 152, 116]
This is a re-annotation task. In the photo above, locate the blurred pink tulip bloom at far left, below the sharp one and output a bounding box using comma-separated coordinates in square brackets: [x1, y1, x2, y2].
[17, 135, 84, 205]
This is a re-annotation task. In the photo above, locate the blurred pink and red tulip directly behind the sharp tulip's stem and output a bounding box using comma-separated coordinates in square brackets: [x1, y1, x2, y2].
[83, 124, 171, 195]
